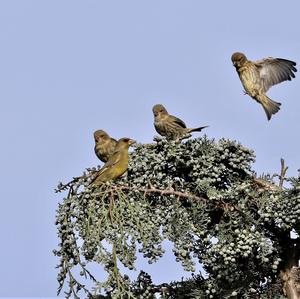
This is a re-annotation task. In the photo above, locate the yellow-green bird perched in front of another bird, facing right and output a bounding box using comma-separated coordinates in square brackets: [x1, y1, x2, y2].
[92, 137, 135, 186]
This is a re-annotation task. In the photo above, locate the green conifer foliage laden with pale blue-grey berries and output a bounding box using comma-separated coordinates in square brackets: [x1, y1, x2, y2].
[54, 136, 300, 299]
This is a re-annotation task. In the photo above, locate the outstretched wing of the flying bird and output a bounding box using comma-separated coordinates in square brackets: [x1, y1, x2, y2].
[254, 57, 297, 92]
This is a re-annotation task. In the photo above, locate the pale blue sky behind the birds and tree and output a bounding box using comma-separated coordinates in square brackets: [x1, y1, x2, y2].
[0, 0, 300, 297]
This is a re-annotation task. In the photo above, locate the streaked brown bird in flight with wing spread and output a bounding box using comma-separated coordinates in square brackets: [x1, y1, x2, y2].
[231, 52, 297, 120]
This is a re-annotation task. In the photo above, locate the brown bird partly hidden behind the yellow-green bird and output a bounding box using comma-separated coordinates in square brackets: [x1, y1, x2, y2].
[94, 130, 117, 162]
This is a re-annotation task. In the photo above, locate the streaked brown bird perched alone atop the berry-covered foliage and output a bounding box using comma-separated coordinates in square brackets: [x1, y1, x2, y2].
[152, 104, 208, 140]
